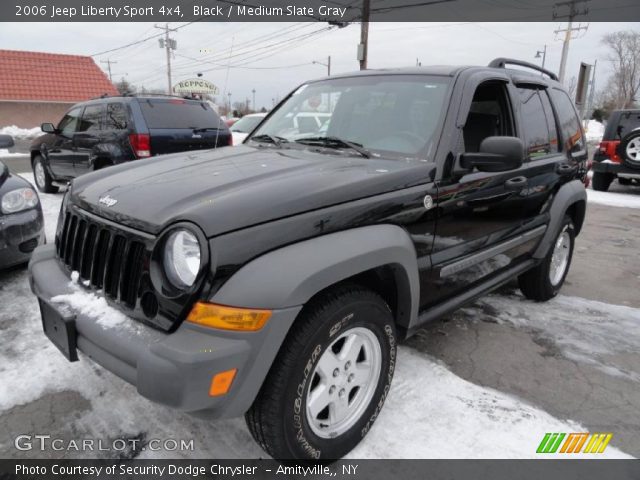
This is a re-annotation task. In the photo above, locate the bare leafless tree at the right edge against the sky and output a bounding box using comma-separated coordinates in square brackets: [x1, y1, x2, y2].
[602, 30, 640, 108]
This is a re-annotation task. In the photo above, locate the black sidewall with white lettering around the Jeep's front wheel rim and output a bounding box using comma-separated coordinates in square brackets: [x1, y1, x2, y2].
[284, 299, 397, 459]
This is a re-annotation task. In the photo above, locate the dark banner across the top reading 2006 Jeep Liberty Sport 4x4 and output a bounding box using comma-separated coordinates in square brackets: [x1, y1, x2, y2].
[0, 0, 640, 23]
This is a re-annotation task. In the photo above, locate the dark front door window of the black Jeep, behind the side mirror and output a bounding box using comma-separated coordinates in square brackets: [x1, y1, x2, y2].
[462, 82, 514, 152]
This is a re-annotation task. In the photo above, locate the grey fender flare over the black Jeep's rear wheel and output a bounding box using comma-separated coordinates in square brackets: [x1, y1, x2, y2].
[533, 180, 587, 259]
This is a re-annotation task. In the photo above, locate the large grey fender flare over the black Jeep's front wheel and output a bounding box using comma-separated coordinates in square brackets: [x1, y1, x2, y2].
[211, 225, 420, 327]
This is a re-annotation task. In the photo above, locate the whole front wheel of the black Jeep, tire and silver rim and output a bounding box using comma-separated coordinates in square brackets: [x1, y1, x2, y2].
[245, 285, 397, 460]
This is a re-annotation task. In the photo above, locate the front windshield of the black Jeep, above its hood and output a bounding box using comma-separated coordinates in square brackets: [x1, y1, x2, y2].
[251, 75, 451, 158]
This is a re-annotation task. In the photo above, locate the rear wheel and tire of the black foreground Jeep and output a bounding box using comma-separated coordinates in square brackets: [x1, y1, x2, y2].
[518, 215, 575, 302]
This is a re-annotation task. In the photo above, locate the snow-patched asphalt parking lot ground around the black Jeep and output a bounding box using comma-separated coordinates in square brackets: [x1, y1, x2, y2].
[0, 163, 640, 458]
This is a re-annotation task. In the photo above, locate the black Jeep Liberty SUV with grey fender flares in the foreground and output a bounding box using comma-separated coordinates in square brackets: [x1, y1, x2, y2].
[30, 59, 587, 459]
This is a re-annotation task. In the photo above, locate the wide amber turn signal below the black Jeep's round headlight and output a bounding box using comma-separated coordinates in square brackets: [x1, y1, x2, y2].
[187, 302, 271, 332]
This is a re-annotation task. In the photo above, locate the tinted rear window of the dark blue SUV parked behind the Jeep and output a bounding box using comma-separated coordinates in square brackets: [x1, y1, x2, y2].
[140, 98, 223, 128]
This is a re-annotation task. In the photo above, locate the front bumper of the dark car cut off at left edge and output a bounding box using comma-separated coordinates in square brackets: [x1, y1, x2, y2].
[0, 208, 45, 268]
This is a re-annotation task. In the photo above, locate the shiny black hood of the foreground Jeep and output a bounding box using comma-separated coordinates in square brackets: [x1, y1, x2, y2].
[71, 145, 433, 237]
